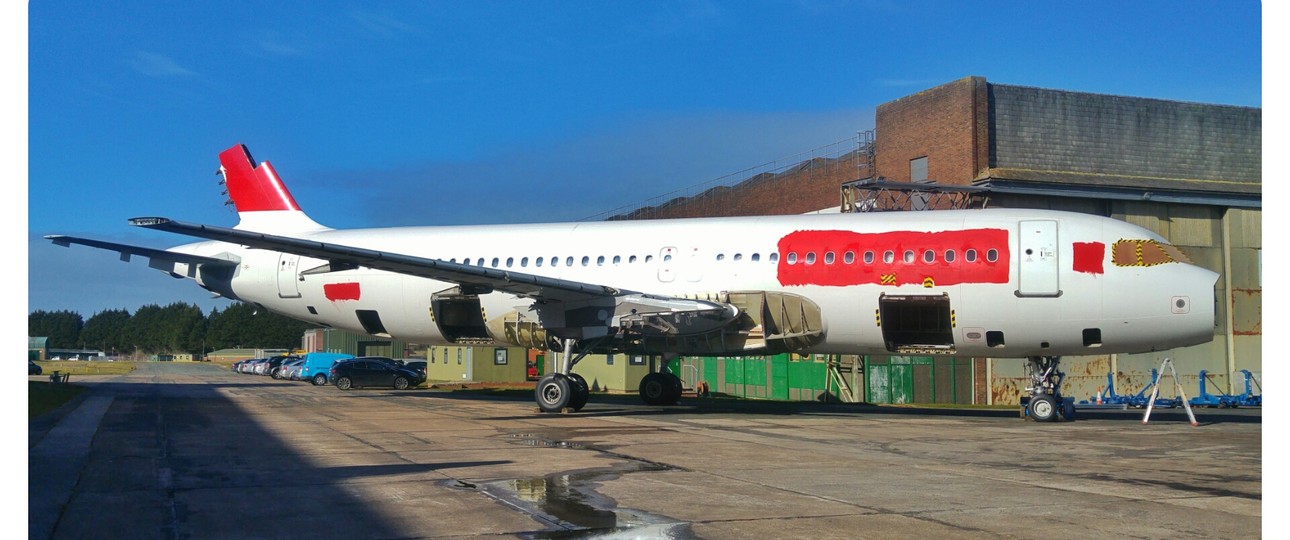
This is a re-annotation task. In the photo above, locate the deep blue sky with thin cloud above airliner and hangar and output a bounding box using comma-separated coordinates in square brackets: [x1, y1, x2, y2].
[25, 0, 1264, 318]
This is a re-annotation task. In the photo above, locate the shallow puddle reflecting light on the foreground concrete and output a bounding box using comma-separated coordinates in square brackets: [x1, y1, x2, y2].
[481, 433, 694, 539]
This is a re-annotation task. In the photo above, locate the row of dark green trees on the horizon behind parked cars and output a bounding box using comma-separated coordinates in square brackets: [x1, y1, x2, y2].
[27, 302, 316, 356]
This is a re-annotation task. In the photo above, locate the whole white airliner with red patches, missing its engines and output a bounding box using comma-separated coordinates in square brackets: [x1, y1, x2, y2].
[46, 144, 1218, 421]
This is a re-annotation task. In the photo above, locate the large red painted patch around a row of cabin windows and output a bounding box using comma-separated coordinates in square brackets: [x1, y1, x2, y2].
[778, 228, 1010, 286]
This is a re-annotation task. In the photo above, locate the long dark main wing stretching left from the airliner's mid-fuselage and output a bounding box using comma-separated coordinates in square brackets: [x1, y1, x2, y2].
[130, 218, 639, 302]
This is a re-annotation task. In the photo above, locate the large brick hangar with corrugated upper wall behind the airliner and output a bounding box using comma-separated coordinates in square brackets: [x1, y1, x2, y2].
[624, 77, 1263, 403]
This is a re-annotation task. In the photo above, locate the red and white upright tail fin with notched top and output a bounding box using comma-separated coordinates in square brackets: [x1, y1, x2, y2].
[219, 144, 326, 233]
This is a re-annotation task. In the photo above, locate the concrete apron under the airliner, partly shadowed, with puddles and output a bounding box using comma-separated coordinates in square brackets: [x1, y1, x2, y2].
[28, 363, 1263, 539]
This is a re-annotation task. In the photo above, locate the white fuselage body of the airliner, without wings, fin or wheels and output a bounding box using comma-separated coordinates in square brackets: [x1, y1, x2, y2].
[175, 210, 1216, 357]
